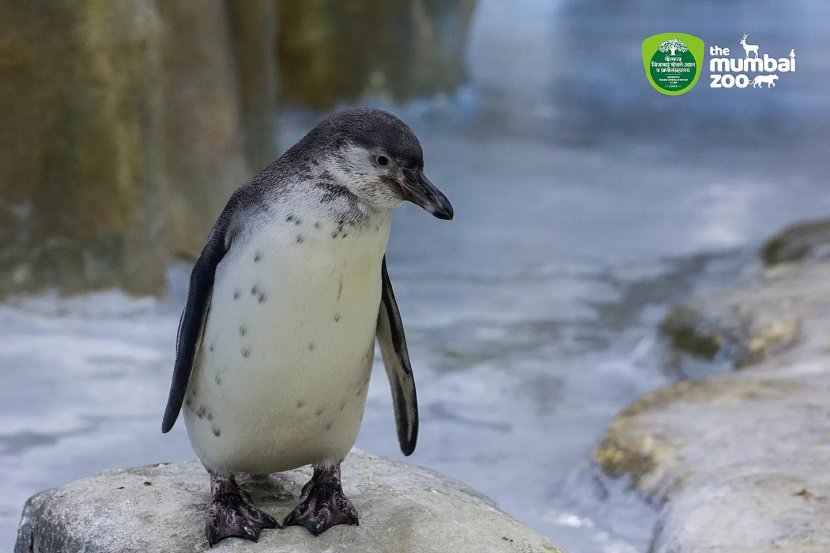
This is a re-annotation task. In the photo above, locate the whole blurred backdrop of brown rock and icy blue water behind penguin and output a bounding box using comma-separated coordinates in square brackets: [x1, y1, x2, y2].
[0, 0, 830, 553]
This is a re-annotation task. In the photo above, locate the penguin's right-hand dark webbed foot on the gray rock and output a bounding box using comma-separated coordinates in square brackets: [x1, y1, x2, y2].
[284, 463, 358, 536]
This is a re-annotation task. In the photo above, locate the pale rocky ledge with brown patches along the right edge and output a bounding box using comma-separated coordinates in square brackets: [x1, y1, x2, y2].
[595, 223, 830, 553]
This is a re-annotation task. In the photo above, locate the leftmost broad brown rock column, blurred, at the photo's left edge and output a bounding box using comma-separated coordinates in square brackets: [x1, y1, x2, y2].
[0, 0, 165, 295]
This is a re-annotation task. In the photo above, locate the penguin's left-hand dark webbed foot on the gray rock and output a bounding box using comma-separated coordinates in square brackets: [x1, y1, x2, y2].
[205, 473, 279, 547]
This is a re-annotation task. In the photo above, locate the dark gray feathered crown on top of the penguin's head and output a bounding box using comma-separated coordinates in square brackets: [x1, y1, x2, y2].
[292, 108, 424, 167]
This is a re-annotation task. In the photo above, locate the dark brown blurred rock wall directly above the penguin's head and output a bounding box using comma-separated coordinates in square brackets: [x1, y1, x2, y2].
[277, 0, 476, 109]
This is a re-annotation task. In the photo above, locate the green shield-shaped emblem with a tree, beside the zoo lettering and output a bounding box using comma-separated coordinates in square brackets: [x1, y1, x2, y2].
[643, 33, 705, 96]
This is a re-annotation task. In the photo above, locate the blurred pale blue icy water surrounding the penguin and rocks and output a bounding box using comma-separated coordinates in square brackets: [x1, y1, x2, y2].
[0, 0, 830, 553]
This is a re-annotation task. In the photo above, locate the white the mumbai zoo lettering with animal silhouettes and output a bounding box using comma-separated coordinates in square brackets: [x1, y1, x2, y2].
[709, 34, 795, 88]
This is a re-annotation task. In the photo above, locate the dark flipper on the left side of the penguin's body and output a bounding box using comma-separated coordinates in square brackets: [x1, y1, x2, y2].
[161, 197, 236, 433]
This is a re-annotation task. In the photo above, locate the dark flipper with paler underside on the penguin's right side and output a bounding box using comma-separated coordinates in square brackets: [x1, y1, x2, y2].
[377, 256, 418, 455]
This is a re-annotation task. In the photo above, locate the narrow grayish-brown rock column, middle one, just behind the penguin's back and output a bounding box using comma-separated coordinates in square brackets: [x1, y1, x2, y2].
[157, 0, 277, 257]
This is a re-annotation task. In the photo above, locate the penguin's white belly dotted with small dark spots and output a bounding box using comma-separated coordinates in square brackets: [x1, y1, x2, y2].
[184, 209, 389, 474]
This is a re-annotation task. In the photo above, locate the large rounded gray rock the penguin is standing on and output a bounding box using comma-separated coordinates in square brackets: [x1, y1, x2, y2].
[15, 450, 561, 553]
